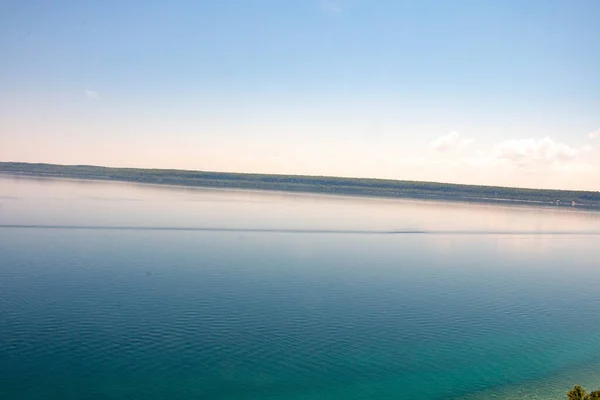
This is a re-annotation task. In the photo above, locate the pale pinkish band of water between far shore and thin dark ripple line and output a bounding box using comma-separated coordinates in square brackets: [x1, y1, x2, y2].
[0, 175, 600, 232]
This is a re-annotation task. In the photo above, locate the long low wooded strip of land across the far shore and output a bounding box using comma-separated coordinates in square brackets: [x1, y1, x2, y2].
[0, 162, 600, 209]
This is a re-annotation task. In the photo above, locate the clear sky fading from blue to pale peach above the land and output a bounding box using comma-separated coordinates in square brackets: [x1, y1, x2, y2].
[0, 0, 600, 191]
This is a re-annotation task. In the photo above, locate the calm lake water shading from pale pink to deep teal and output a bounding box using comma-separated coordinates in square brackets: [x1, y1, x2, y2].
[0, 176, 600, 400]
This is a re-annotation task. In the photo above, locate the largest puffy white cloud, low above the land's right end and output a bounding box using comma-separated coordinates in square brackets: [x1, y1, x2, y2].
[496, 137, 590, 168]
